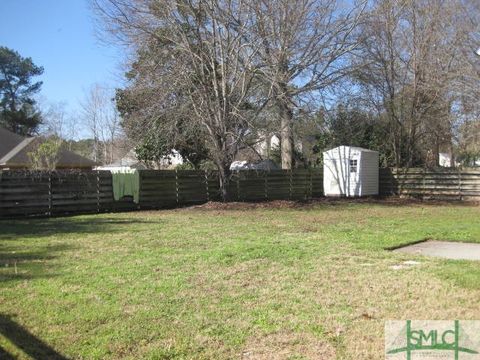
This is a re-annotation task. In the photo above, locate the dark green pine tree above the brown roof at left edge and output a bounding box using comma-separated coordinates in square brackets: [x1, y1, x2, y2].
[0, 46, 43, 135]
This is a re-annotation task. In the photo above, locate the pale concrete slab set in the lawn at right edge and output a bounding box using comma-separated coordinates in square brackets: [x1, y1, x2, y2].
[394, 240, 480, 260]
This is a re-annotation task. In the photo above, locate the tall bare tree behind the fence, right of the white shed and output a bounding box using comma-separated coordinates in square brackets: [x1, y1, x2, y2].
[355, 0, 480, 166]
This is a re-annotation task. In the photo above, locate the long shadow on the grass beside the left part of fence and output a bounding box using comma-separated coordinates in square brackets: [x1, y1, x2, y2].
[0, 215, 160, 241]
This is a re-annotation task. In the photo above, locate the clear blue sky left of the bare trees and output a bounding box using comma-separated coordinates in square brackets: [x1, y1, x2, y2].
[0, 0, 121, 121]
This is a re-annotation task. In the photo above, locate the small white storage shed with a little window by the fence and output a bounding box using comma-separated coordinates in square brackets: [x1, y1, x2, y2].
[323, 145, 379, 196]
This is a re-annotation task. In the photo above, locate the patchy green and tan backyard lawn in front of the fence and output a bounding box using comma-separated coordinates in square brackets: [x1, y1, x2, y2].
[0, 201, 480, 360]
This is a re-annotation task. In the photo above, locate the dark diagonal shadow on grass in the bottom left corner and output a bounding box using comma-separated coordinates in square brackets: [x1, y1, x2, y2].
[0, 314, 68, 360]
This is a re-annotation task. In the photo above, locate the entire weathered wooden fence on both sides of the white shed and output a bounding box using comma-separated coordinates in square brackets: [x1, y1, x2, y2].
[0, 169, 480, 218]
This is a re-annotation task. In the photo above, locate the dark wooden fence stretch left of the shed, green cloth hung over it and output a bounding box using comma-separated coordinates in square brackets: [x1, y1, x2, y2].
[0, 170, 323, 218]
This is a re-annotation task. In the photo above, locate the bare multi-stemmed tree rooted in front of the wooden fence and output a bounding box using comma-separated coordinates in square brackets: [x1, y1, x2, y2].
[94, 0, 257, 199]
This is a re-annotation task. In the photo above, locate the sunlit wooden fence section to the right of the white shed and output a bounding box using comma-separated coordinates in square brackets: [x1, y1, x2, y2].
[380, 168, 480, 201]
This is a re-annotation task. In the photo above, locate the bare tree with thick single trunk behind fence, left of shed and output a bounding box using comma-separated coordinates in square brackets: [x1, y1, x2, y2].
[251, 0, 366, 169]
